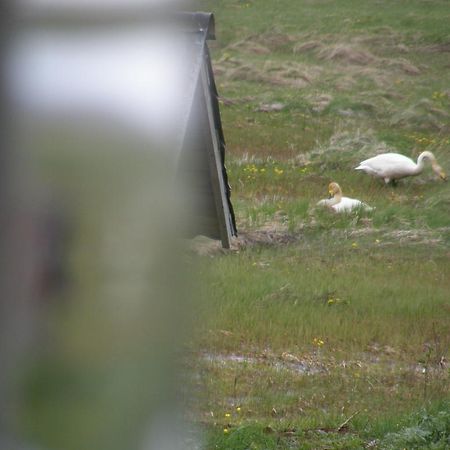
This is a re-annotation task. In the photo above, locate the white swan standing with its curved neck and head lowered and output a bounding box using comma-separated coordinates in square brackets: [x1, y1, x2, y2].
[355, 151, 447, 184]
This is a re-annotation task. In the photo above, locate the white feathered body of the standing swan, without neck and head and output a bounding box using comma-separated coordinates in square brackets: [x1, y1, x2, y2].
[356, 153, 417, 178]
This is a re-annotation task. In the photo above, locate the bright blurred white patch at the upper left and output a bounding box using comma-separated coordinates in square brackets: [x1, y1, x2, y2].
[9, 28, 197, 142]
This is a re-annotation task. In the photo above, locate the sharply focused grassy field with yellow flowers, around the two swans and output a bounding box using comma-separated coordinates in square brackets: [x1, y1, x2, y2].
[193, 0, 450, 450]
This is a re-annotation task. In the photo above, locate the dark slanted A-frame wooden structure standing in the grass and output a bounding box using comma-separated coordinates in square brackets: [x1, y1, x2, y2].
[180, 13, 237, 248]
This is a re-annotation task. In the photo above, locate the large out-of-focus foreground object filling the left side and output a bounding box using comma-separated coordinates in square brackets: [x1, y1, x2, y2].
[0, 1, 229, 450]
